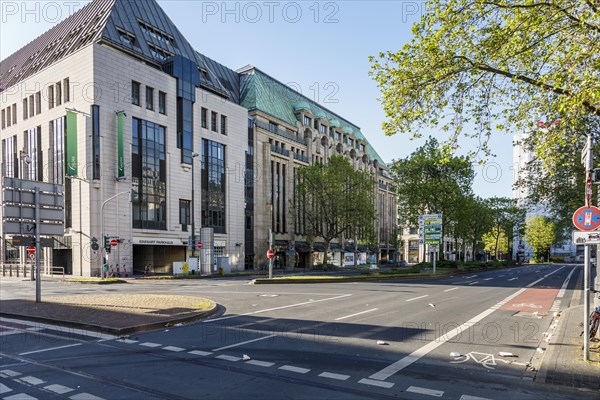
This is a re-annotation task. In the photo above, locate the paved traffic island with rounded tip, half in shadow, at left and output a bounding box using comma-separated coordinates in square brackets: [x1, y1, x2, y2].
[0, 294, 217, 335]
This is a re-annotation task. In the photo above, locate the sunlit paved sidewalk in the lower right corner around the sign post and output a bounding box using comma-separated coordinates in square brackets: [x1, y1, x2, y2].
[536, 305, 600, 391]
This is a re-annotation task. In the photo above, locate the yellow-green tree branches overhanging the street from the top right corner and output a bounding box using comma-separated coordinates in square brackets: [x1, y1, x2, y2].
[370, 0, 600, 155]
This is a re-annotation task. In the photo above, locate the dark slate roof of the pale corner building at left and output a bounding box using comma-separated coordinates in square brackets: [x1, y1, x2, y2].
[0, 0, 232, 98]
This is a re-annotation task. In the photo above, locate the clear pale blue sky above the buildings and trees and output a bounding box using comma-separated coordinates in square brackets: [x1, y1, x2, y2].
[0, 0, 513, 197]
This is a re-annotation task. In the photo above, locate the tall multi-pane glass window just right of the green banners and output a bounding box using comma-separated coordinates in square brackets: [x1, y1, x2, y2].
[131, 118, 167, 230]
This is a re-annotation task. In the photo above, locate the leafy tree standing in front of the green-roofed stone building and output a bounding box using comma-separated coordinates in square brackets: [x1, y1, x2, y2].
[290, 155, 376, 264]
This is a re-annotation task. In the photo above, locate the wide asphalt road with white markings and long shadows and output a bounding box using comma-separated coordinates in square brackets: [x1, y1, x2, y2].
[0, 265, 597, 400]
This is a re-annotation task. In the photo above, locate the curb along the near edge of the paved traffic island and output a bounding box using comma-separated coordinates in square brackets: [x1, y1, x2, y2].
[0, 300, 219, 336]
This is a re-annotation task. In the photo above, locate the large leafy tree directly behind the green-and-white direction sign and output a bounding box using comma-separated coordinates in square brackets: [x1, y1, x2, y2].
[392, 138, 474, 258]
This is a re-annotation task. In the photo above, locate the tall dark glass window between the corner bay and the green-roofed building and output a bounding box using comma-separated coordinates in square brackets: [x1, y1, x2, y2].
[201, 139, 227, 233]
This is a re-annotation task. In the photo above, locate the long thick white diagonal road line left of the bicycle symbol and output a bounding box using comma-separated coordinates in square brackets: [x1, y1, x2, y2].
[369, 288, 525, 381]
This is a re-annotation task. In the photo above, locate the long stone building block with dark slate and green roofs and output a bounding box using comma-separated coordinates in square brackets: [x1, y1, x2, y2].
[0, 0, 395, 276]
